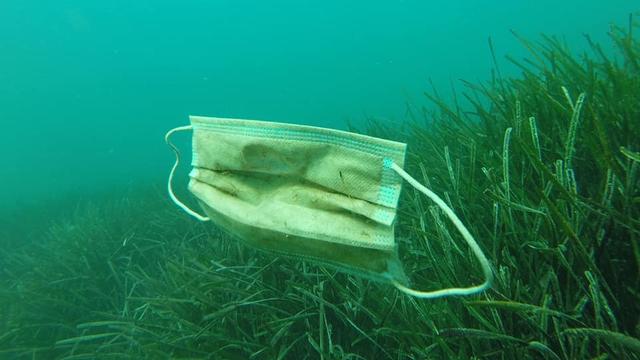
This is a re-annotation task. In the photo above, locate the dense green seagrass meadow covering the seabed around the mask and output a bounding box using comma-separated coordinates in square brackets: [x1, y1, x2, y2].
[0, 19, 640, 360]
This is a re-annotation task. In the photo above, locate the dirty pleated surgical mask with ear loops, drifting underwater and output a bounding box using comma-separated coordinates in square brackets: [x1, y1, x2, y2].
[165, 116, 492, 298]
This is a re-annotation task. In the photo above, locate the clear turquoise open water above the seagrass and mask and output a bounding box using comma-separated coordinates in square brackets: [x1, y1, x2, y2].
[0, 0, 638, 212]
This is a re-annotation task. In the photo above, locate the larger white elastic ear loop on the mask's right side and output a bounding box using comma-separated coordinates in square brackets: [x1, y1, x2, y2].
[391, 163, 493, 299]
